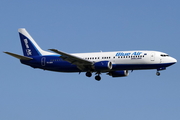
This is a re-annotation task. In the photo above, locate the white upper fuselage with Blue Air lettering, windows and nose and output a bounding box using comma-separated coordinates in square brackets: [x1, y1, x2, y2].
[72, 51, 177, 65]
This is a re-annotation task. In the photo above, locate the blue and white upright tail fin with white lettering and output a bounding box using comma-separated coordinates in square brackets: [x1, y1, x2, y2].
[18, 28, 52, 57]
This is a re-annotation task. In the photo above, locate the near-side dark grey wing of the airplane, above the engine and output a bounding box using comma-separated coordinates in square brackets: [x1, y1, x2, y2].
[49, 49, 93, 69]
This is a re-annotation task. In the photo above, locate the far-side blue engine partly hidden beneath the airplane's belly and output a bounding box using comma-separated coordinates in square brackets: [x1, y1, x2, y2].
[109, 70, 129, 77]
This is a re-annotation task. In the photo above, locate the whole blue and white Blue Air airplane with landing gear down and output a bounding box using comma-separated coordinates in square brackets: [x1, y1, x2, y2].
[4, 28, 177, 81]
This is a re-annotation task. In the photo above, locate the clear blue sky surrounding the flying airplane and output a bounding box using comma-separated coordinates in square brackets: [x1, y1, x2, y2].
[0, 0, 180, 120]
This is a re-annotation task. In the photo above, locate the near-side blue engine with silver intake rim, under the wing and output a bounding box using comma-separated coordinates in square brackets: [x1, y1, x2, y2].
[93, 61, 112, 71]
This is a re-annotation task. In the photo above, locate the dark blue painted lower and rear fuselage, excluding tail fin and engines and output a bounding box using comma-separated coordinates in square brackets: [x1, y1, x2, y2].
[21, 55, 174, 72]
